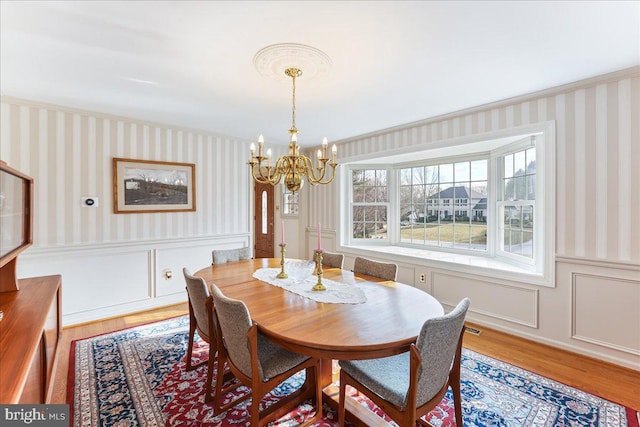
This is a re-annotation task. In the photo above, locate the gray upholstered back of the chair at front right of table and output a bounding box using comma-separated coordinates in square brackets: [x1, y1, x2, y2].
[416, 298, 470, 406]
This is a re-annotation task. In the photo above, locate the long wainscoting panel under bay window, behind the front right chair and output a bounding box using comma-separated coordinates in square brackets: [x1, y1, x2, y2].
[431, 272, 538, 328]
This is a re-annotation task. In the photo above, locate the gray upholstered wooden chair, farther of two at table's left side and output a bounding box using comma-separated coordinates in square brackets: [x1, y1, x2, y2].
[182, 268, 230, 402]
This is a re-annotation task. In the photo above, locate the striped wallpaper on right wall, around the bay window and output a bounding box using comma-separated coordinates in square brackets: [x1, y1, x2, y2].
[308, 67, 640, 264]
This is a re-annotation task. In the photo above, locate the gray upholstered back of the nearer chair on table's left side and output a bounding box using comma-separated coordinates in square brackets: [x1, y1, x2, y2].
[209, 284, 262, 378]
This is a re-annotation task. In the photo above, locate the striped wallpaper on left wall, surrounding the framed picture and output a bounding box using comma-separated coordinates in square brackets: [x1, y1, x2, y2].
[0, 97, 251, 248]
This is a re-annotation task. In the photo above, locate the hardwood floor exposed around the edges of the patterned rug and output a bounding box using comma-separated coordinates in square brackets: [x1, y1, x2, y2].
[52, 303, 640, 411]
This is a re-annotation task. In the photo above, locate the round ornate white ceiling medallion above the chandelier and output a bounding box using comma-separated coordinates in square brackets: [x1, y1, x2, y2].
[253, 43, 333, 80]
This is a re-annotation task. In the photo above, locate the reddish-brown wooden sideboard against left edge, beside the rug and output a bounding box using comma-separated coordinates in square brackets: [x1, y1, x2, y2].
[0, 275, 62, 404]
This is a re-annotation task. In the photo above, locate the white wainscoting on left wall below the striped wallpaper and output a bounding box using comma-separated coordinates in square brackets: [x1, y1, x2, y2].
[18, 233, 250, 326]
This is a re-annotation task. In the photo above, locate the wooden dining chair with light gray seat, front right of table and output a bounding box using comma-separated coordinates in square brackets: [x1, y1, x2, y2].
[338, 298, 470, 427]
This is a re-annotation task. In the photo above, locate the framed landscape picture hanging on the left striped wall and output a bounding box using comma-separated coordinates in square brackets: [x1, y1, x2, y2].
[113, 158, 196, 213]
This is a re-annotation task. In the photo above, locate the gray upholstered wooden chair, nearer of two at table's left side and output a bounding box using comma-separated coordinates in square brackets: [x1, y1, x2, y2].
[209, 284, 322, 427]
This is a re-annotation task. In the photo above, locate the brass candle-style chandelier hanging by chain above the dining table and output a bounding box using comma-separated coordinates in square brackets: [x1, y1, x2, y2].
[249, 68, 338, 193]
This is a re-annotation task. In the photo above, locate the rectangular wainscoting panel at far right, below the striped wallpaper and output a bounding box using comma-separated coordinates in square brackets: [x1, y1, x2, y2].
[571, 273, 640, 356]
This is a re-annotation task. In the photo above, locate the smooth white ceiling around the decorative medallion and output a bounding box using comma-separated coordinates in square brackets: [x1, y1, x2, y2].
[0, 0, 640, 146]
